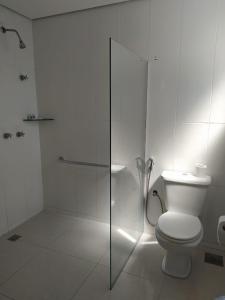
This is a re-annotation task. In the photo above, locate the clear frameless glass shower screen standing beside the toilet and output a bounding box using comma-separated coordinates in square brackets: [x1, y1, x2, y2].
[110, 39, 147, 288]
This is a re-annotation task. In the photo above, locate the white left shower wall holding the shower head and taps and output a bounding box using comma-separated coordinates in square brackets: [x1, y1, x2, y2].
[0, 6, 42, 234]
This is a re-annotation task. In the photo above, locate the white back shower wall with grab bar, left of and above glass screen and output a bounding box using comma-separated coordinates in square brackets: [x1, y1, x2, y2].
[33, 0, 149, 221]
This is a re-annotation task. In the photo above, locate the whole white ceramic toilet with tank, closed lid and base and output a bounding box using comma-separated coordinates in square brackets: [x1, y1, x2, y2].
[155, 171, 211, 278]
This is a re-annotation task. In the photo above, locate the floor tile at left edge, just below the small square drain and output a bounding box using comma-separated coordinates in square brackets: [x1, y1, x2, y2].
[0, 237, 40, 284]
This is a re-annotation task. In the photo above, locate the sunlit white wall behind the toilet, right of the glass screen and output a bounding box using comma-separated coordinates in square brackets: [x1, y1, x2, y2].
[147, 0, 225, 246]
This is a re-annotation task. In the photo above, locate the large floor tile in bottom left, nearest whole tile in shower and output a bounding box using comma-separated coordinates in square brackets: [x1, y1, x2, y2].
[0, 252, 94, 300]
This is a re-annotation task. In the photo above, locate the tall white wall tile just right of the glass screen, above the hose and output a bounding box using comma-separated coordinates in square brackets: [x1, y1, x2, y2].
[146, 0, 181, 173]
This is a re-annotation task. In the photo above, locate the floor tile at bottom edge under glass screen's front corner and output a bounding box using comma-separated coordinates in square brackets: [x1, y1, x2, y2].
[73, 265, 154, 300]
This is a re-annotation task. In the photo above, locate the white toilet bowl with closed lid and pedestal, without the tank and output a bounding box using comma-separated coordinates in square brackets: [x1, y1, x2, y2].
[155, 212, 203, 279]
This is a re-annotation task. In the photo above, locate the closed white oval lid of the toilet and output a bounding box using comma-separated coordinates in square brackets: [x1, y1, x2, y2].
[158, 212, 202, 241]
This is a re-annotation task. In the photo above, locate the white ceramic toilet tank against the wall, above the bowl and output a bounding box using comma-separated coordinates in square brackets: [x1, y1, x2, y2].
[161, 171, 211, 216]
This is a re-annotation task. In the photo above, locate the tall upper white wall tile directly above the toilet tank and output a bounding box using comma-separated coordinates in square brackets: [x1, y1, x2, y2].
[178, 0, 218, 122]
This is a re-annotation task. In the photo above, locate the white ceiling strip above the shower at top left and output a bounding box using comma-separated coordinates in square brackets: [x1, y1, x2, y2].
[0, 0, 129, 19]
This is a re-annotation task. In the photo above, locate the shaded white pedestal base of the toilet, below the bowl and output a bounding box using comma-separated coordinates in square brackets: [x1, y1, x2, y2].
[162, 251, 191, 279]
